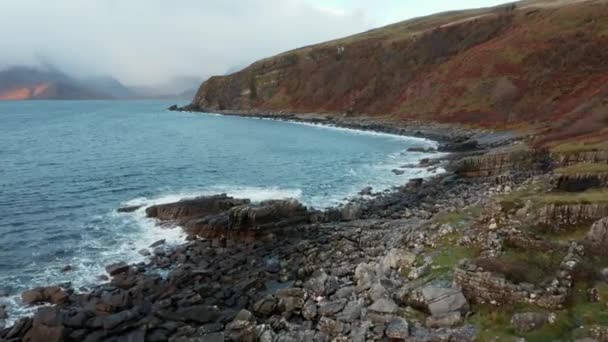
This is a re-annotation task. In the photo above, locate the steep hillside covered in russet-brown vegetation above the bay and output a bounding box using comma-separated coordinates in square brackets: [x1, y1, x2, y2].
[191, 0, 608, 146]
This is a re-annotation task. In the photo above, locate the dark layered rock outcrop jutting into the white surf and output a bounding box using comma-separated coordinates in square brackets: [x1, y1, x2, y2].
[146, 194, 310, 240]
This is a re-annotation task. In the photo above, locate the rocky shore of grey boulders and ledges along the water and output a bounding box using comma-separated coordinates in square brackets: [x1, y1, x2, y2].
[0, 116, 608, 342]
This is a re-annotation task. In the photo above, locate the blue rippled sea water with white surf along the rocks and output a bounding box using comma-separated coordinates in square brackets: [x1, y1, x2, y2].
[0, 101, 435, 319]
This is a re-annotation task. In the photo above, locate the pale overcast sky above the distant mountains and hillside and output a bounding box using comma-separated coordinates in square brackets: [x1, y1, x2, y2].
[0, 0, 505, 85]
